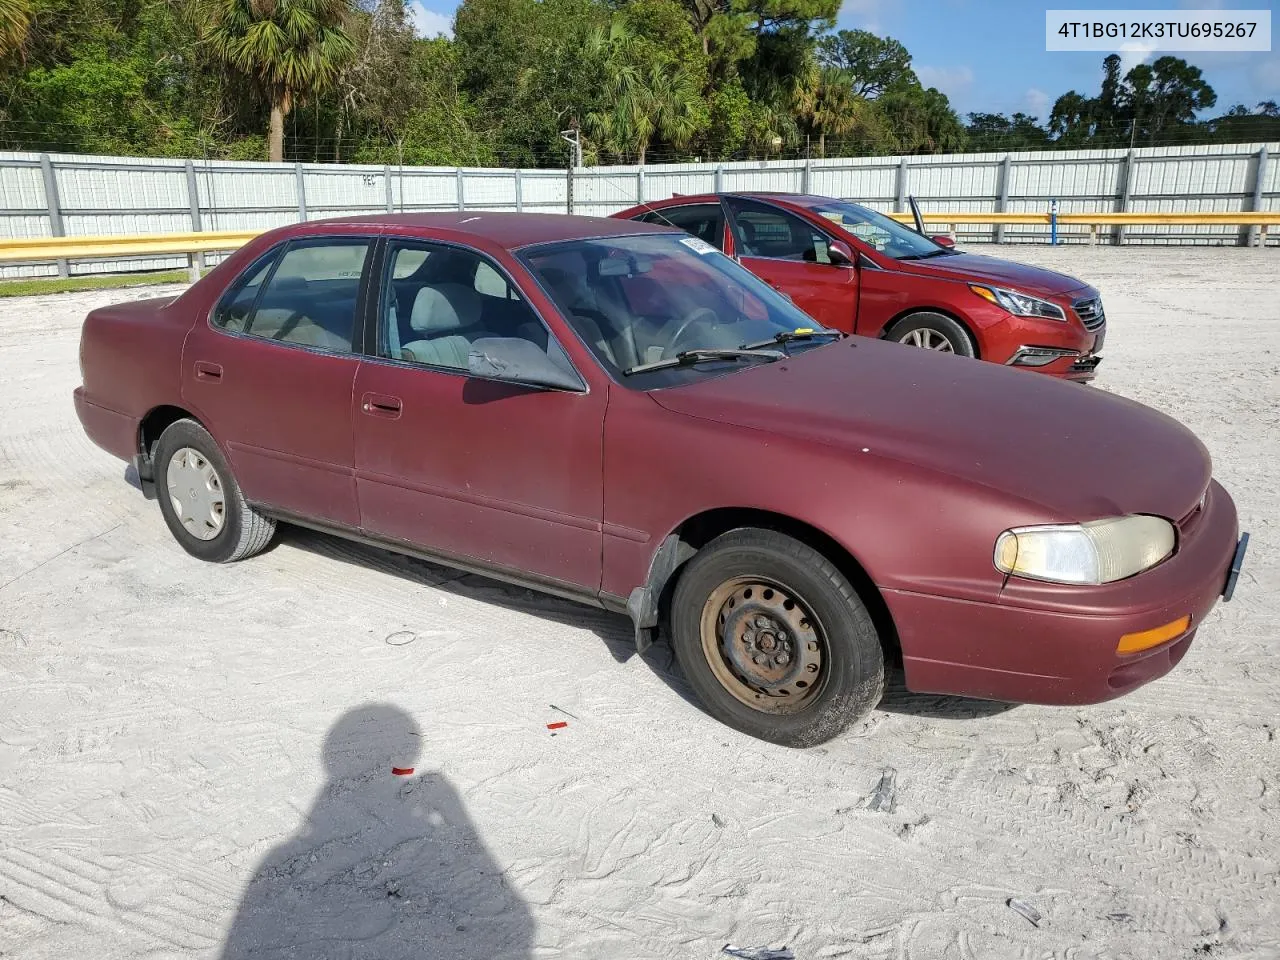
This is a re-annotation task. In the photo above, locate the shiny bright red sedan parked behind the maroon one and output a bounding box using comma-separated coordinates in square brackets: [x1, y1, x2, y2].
[614, 193, 1106, 381]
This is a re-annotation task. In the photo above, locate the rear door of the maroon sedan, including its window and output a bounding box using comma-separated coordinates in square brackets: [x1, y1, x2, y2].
[182, 237, 372, 526]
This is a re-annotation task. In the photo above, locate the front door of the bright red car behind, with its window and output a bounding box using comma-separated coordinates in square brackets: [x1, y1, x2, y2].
[726, 197, 858, 333]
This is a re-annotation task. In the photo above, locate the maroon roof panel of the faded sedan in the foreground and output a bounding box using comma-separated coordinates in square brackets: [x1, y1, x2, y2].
[294, 210, 676, 250]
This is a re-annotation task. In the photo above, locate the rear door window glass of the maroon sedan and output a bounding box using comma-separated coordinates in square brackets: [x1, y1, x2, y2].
[214, 238, 369, 353]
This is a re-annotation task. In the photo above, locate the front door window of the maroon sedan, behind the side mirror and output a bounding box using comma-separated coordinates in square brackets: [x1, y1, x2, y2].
[378, 241, 572, 371]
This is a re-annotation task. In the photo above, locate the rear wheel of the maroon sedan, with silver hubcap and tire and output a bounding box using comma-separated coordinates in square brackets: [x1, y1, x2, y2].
[152, 420, 275, 563]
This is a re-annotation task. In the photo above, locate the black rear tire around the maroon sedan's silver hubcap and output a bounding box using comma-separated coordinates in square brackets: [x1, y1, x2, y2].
[151, 420, 275, 563]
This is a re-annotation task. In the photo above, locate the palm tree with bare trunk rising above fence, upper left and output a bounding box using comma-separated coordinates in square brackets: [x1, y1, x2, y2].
[203, 0, 353, 163]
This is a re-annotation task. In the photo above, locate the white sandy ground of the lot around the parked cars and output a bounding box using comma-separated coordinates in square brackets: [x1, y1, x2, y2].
[0, 247, 1280, 960]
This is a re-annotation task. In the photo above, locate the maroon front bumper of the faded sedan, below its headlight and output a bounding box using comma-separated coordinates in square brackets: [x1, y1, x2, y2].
[884, 483, 1239, 704]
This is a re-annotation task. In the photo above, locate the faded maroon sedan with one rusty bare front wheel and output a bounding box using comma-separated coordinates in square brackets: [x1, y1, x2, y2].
[76, 214, 1243, 745]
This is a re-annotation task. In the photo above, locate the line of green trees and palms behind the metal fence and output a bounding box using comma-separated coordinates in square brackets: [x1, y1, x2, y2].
[0, 0, 1259, 166]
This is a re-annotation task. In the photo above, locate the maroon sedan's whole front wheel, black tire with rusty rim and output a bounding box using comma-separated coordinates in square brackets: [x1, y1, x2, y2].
[671, 527, 884, 748]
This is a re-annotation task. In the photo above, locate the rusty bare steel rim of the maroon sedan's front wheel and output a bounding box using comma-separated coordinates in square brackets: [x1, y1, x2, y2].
[700, 577, 827, 713]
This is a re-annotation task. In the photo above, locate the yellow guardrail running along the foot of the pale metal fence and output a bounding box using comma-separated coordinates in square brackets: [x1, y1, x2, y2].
[0, 210, 1280, 273]
